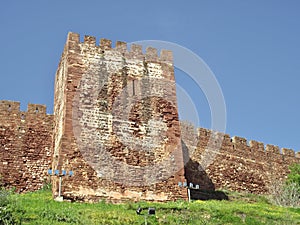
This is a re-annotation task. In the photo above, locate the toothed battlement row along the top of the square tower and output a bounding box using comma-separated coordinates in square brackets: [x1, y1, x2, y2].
[67, 32, 173, 64]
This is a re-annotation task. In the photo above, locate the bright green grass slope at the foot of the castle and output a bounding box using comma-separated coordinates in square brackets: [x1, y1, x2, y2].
[7, 190, 300, 225]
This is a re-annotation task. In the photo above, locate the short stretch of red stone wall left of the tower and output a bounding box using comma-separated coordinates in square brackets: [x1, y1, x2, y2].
[0, 100, 53, 192]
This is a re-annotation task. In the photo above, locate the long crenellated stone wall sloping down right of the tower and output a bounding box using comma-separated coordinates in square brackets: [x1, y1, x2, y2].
[183, 124, 300, 194]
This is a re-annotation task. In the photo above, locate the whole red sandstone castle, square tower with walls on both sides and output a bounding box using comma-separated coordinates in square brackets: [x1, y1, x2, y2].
[0, 33, 300, 202]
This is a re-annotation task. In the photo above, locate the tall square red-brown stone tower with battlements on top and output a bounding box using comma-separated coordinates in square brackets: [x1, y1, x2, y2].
[52, 33, 187, 202]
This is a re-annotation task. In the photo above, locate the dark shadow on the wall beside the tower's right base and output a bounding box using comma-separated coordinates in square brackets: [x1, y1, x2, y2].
[181, 141, 228, 200]
